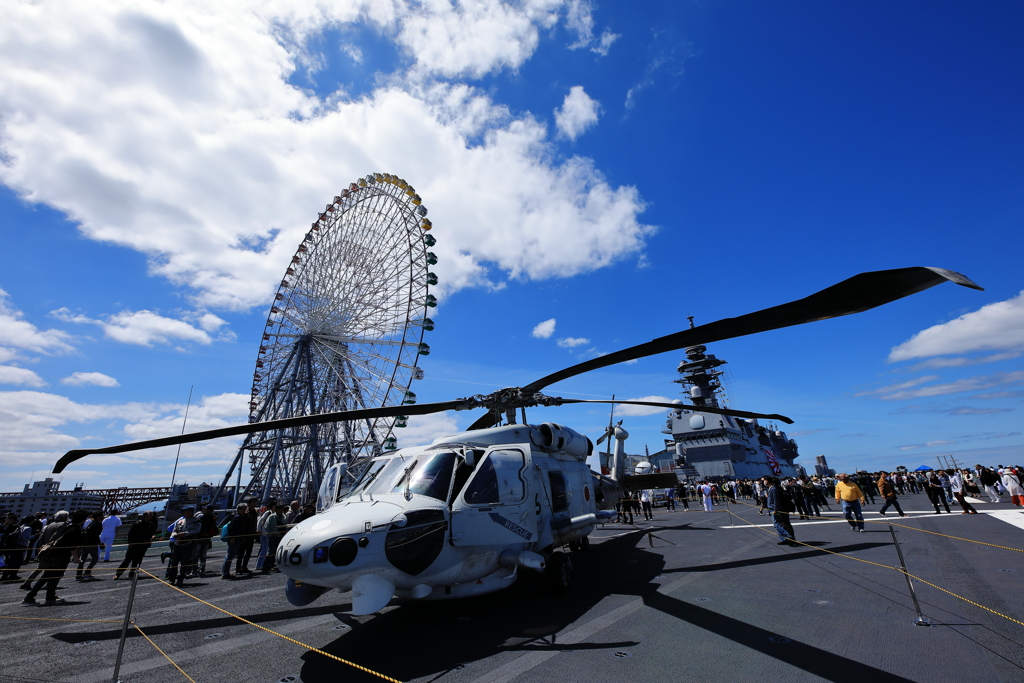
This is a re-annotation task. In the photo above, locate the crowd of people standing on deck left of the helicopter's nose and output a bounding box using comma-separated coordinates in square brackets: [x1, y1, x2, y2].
[0, 498, 314, 606]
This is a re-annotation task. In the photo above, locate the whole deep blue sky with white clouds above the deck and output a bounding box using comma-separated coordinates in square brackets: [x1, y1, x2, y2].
[0, 0, 1024, 490]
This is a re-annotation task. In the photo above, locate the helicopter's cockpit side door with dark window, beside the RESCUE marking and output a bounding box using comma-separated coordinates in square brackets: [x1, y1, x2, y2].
[452, 445, 537, 546]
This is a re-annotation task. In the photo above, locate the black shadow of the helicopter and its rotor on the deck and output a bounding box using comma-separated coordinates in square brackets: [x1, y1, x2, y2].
[301, 525, 904, 683]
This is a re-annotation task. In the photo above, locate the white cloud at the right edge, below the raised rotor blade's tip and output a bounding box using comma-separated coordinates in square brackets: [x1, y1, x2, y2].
[889, 292, 1024, 361]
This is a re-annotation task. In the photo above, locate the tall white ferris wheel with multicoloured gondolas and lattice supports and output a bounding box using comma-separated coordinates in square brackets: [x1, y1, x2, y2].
[214, 173, 437, 502]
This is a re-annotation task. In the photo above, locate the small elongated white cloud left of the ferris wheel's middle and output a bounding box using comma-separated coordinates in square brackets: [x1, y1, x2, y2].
[50, 308, 227, 346]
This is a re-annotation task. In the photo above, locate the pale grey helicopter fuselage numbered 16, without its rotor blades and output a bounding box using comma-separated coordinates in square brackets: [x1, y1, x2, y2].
[278, 423, 617, 614]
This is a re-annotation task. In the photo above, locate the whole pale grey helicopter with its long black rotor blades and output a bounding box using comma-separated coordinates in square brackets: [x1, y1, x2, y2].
[53, 267, 982, 614]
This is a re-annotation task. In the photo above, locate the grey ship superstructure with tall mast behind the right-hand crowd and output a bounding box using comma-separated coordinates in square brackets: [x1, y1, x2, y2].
[662, 339, 804, 479]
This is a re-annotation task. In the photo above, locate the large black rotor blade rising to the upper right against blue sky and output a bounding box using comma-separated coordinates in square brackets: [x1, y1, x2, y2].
[524, 266, 982, 395]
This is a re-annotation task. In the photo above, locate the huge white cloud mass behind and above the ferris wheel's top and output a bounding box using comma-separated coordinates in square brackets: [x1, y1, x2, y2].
[0, 0, 652, 311]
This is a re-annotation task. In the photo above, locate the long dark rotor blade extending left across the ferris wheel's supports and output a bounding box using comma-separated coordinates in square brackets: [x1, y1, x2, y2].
[53, 400, 463, 474]
